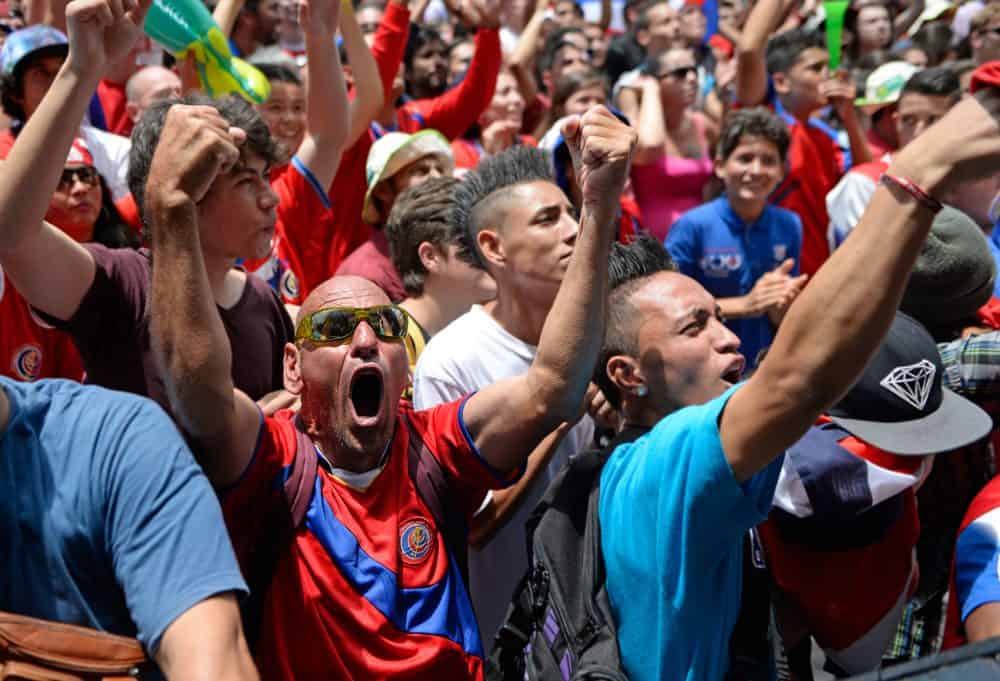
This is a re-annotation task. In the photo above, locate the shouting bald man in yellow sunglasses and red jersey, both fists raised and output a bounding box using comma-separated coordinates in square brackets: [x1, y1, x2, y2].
[148, 107, 635, 680]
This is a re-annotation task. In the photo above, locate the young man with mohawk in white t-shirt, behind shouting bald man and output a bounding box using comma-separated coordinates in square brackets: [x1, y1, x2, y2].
[413, 146, 604, 641]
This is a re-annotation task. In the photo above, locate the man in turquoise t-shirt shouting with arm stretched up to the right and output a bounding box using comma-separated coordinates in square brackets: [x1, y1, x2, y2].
[595, 94, 1000, 681]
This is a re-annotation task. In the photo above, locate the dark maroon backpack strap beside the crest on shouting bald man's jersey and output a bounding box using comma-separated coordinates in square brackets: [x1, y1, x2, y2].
[403, 414, 469, 584]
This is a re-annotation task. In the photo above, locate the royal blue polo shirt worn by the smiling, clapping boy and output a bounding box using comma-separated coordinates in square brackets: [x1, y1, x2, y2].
[666, 196, 802, 368]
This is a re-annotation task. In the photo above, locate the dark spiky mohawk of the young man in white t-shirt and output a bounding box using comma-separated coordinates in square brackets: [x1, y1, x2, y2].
[452, 145, 555, 266]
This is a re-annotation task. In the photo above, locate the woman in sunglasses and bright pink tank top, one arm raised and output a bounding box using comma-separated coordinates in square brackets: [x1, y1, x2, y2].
[632, 48, 713, 241]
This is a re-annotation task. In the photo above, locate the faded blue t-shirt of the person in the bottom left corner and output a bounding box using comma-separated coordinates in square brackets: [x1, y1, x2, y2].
[0, 377, 246, 656]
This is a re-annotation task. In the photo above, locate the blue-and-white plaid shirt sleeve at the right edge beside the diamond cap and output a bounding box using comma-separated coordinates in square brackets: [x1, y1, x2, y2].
[938, 331, 1000, 400]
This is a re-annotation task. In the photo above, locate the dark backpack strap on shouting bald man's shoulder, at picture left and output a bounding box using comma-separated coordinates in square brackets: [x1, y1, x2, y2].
[242, 419, 319, 652]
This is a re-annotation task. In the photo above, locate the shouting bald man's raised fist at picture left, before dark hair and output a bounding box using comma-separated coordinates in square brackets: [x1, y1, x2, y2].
[145, 104, 246, 216]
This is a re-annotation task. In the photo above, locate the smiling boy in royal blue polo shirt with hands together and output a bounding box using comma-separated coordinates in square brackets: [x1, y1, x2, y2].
[666, 107, 806, 368]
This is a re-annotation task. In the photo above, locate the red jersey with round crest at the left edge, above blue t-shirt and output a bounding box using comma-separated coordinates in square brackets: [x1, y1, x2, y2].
[0, 269, 83, 381]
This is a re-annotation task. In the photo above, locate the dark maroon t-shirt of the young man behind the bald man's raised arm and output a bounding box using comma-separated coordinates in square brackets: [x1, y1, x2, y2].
[42, 244, 295, 408]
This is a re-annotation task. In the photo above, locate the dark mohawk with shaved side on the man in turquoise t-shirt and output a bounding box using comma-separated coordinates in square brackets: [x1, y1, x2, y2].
[594, 232, 677, 409]
